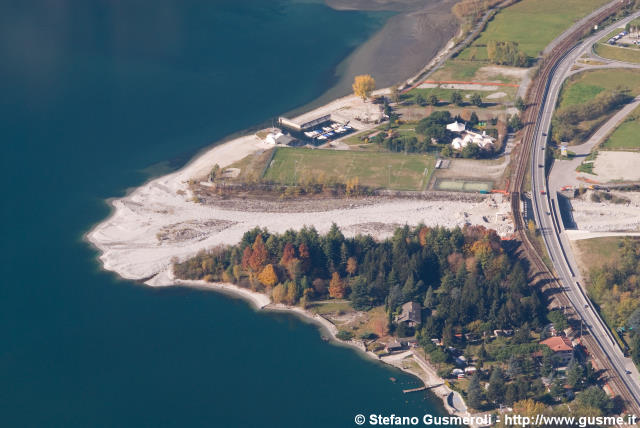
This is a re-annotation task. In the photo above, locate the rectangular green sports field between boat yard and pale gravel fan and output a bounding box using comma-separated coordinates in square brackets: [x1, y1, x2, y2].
[265, 147, 435, 190]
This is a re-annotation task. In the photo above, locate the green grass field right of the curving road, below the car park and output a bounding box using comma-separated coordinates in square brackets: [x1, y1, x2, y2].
[559, 69, 640, 107]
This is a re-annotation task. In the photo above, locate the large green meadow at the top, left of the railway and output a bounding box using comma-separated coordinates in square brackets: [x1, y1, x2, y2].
[459, 0, 608, 60]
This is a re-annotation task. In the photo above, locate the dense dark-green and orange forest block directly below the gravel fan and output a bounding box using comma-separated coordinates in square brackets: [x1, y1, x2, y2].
[174, 225, 546, 337]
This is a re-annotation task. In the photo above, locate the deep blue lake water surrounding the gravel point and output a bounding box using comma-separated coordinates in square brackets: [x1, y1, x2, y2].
[0, 0, 452, 427]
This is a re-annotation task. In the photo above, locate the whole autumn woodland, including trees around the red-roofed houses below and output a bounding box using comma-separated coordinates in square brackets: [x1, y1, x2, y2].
[174, 224, 613, 414]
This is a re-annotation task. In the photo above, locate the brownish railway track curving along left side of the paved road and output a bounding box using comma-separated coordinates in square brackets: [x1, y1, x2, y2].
[509, 3, 640, 414]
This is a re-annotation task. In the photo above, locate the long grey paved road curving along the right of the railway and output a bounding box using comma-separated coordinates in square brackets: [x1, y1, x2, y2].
[531, 8, 640, 409]
